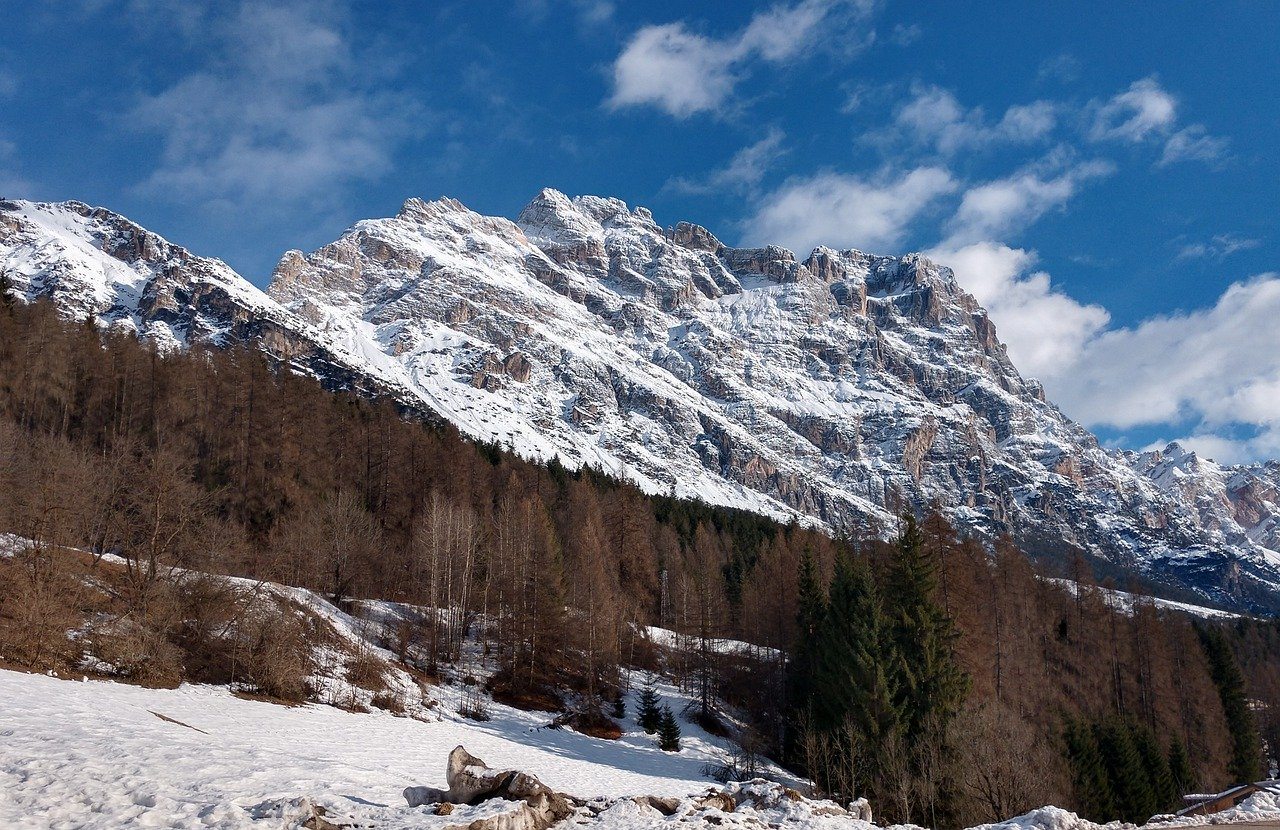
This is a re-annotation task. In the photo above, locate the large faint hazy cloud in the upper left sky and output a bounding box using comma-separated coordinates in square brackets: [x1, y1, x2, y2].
[125, 1, 416, 208]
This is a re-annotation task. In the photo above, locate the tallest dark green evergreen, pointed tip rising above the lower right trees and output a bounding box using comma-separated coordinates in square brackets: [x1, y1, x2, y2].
[888, 514, 969, 745]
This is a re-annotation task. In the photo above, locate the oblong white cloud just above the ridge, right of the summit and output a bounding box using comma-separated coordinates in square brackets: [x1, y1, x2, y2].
[742, 167, 956, 255]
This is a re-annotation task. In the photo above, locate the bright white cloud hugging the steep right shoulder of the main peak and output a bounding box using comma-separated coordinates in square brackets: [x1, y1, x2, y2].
[928, 242, 1111, 378]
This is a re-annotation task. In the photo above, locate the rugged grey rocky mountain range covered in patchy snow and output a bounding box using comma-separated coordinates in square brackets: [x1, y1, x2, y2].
[0, 190, 1280, 607]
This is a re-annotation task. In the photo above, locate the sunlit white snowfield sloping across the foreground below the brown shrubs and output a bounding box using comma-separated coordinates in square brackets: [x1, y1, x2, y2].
[0, 671, 757, 827]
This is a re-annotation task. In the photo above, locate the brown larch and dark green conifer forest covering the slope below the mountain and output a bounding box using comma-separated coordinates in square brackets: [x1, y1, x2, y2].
[0, 291, 1280, 826]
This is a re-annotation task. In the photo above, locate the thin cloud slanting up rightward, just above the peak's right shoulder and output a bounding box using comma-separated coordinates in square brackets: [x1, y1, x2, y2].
[940, 154, 1114, 250]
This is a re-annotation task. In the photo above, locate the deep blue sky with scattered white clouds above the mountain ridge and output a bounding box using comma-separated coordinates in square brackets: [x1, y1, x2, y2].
[0, 0, 1280, 461]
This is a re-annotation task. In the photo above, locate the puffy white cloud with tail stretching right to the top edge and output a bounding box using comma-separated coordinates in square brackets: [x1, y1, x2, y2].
[608, 0, 869, 118]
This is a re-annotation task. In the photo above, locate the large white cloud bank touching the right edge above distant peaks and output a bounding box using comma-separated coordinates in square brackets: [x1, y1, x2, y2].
[1044, 273, 1280, 461]
